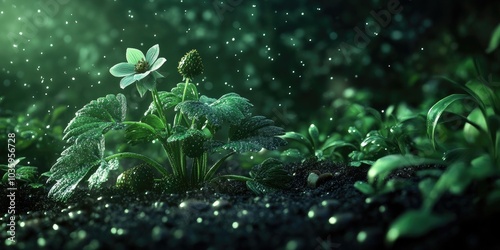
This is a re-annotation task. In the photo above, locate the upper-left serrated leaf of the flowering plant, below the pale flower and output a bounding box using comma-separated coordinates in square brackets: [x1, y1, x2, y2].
[63, 94, 127, 143]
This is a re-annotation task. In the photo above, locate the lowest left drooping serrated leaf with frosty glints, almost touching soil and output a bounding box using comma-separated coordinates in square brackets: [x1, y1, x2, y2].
[47, 135, 108, 201]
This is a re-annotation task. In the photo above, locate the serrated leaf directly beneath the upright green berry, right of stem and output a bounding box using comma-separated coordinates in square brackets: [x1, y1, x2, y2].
[175, 93, 252, 127]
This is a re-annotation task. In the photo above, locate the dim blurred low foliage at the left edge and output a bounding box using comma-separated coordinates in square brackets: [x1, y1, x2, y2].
[0, 97, 66, 188]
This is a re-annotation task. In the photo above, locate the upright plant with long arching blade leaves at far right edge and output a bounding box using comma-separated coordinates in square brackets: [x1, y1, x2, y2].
[424, 60, 500, 208]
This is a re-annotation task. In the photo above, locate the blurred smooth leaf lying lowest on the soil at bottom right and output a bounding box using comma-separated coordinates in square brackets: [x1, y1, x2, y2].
[386, 210, 454, 243]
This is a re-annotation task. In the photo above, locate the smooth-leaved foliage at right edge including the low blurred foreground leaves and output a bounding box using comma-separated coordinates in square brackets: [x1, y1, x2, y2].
[355, 62, 500, 243]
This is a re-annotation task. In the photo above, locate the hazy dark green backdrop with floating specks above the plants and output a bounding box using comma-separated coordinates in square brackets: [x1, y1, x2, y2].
[0, 0, 500, 168]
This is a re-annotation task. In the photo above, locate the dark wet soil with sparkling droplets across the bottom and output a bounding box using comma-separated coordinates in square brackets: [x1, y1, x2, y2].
[0, 162, 500, 250]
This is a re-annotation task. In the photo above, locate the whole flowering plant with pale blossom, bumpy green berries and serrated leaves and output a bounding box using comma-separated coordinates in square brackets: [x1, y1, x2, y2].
[49, 45, 288, 200]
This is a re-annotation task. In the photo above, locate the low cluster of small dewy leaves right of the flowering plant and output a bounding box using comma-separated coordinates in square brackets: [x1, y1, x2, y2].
[282, 99, 429, 166]
